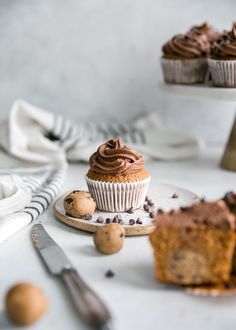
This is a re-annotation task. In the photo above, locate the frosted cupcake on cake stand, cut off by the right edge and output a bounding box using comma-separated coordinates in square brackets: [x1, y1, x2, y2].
[208, 22, 236, 87]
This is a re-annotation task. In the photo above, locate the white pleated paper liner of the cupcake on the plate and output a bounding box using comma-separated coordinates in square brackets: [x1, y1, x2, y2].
[86, 176, 151, 212]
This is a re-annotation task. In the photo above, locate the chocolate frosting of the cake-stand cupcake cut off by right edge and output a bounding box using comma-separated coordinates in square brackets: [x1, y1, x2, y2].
[212, 22, 236, 58]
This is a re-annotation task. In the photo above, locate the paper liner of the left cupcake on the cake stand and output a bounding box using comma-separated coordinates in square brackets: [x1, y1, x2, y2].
[161, 58, 208, 84]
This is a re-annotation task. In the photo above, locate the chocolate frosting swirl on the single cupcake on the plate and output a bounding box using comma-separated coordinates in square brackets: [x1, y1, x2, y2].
[89, 138, 144, 175]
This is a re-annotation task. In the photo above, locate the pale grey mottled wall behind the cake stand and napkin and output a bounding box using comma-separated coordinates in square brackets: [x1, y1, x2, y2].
[0, 0, 236, 143]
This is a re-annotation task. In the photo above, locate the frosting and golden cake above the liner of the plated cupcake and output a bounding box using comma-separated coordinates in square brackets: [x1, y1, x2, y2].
[87, 138, 149, 182]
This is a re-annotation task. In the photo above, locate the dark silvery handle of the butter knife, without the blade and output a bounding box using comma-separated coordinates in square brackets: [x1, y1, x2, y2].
[59, 269, 111, 329]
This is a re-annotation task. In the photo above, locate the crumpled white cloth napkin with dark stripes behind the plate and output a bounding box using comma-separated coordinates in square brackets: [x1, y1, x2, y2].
[0, 100, 204, 243]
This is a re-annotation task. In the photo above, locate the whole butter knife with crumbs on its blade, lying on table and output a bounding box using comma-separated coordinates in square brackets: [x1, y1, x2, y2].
[31, 224, 111, 329]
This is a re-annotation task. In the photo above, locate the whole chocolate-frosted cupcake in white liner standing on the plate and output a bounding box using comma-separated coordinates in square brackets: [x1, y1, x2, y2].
[86, 139, 150, 212]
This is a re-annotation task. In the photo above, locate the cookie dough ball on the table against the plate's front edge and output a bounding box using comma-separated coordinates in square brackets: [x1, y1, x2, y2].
[93, 223, 125, 254]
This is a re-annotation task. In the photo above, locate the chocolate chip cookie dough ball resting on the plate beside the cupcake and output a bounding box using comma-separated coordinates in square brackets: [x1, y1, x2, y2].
[64, 190, 96, 218]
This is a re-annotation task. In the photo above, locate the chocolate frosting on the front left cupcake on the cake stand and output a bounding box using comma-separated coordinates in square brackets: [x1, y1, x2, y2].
[162, 33, 210, 59]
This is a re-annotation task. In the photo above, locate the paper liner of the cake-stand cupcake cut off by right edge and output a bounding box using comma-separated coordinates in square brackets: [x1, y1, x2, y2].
[208, 59, 236, 87]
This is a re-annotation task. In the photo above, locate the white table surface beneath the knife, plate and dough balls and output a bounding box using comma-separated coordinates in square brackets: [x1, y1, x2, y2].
[0, 149, 236, 330]
